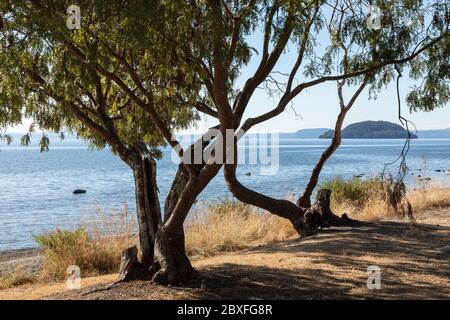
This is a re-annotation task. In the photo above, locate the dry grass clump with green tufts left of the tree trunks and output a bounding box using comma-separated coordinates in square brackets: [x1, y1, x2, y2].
[35, 208, 134, 281]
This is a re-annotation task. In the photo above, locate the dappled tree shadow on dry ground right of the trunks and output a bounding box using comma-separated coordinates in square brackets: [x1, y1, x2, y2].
[191, 222, 450, 299]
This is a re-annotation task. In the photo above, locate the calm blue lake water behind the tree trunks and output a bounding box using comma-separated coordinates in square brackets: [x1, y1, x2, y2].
[0, 139, 450, 250]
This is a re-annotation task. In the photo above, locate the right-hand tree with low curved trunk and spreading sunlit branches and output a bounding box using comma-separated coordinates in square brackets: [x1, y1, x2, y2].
[178, 0, 449, 235]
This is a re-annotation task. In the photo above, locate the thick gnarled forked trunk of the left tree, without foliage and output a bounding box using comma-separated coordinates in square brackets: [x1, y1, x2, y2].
[121, 130, 221, 284]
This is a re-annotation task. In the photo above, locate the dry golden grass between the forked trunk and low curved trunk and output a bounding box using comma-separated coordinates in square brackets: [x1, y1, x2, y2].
[186, 201, 295, 257]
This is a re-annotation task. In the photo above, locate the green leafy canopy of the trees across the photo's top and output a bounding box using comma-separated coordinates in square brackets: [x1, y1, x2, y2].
[0, 0, 450, 149]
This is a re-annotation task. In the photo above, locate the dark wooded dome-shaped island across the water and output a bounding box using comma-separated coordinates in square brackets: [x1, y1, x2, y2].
[319, 121, 417, 139]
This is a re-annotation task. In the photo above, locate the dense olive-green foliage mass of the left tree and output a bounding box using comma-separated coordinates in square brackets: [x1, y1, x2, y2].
[0, 0, 199, 155]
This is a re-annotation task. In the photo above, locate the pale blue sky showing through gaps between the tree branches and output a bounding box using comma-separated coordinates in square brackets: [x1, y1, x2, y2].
[10, 5, 450, 133]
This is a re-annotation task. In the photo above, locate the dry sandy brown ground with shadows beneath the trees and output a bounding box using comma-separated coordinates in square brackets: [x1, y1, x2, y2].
[0, 208, 450, 299]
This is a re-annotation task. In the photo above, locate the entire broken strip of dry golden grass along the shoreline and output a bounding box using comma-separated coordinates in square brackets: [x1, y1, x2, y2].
[4, 182, 450, 290]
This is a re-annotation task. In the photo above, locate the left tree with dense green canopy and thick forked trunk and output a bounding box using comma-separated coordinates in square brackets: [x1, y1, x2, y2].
[0, 1, 218, 283]
